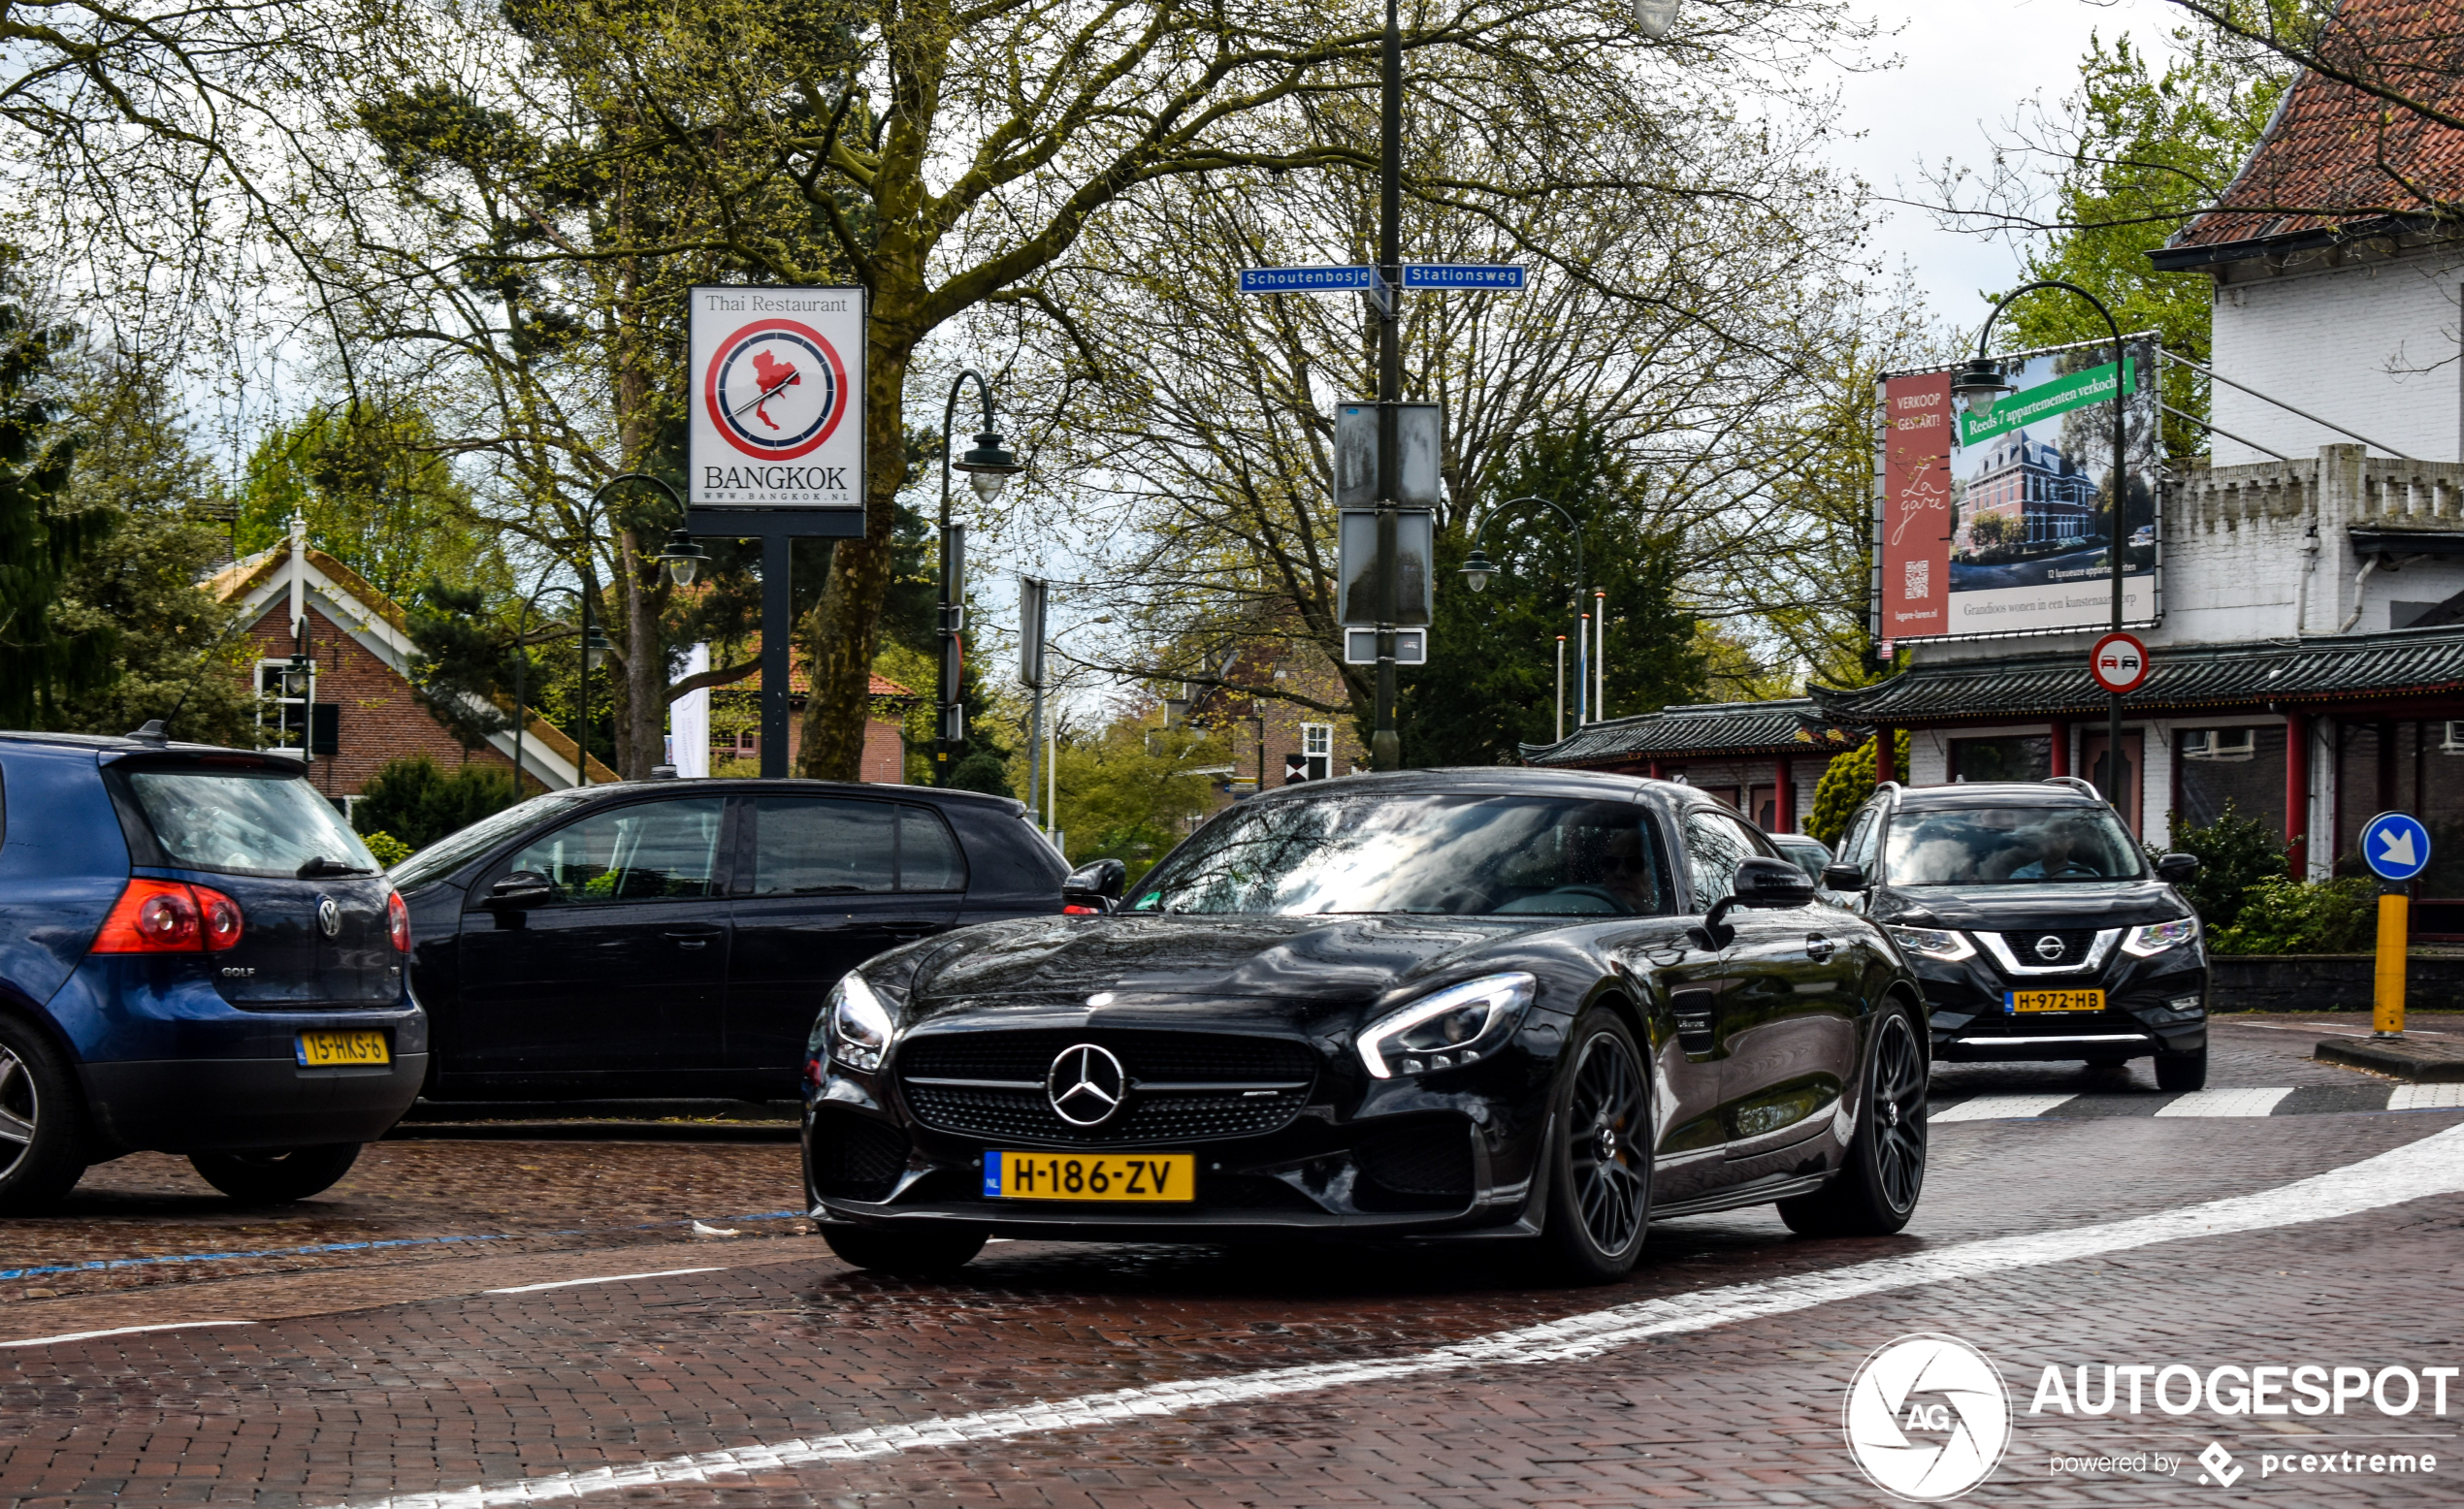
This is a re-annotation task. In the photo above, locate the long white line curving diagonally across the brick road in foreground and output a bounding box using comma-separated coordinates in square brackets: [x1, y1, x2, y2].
[317, 1128, 2464, 1509]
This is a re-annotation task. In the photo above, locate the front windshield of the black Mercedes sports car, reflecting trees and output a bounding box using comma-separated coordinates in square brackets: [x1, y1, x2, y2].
[1123, 792, 1670, 915]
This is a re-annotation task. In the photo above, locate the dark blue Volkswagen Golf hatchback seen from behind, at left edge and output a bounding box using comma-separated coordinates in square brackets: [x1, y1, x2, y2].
[0, 723, 429, 1211]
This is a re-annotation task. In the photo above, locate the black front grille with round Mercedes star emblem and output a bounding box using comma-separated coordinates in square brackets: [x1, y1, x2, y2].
[897, 1029, 1318, 1144]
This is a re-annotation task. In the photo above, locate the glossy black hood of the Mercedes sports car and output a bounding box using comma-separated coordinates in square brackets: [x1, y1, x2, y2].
[901, 915, 1565, 1019]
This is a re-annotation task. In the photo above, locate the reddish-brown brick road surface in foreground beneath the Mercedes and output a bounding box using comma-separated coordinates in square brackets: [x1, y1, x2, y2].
[0, 1112, 2464, 1509]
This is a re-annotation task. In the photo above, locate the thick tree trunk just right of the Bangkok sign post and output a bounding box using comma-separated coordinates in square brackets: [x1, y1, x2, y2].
[795, 325, 914, 781]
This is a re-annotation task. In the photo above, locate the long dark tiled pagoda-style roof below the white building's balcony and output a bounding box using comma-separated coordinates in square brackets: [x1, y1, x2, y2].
[1808, 626, 2464, 726]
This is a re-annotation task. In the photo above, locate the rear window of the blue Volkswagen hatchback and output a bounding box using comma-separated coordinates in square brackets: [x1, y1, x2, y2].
[128, 768, 377, 874]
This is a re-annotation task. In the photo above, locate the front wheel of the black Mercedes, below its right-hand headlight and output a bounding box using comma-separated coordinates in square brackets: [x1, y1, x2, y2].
[1540, 1010, 1651, 1285]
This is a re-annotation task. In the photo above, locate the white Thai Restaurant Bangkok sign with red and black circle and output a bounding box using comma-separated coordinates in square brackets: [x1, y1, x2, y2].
[688, 288, 865, 509]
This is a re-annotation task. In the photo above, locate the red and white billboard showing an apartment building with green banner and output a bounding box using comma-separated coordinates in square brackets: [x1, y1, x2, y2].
[1875, 335, 2161, 643]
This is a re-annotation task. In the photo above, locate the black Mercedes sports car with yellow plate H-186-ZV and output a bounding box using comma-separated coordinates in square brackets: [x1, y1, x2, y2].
[803, 770, 1927, 1280]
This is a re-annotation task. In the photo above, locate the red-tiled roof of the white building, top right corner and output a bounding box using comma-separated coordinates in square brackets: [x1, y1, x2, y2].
[2156, 0, 2464, 250]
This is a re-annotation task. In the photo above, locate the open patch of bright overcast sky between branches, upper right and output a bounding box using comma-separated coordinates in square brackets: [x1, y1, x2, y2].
[1840, 0, 2181, 330]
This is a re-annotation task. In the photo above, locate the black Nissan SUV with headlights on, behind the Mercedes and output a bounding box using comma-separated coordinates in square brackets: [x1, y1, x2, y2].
[1824, 776, 2208, 1090]
